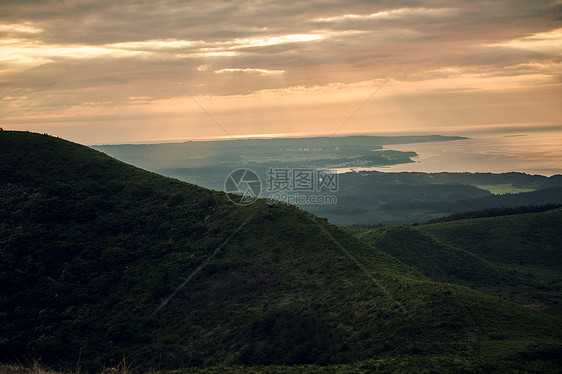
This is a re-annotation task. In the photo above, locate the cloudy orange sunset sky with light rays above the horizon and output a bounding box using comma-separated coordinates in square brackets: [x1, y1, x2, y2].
[0, 0, 562, 147]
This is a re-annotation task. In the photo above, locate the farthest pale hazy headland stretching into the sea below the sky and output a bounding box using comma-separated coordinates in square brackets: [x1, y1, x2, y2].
[92, 135, 468, 170]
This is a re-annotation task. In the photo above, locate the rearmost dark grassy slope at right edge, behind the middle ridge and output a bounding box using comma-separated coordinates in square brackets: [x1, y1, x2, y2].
[420, 211, 562, 304]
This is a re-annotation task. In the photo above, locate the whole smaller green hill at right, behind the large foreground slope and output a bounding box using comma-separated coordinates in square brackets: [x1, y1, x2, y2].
[350, 210, 562, 314]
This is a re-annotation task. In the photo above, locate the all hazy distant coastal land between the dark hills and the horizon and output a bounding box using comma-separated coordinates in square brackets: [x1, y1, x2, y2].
[93, 135, 562, 225]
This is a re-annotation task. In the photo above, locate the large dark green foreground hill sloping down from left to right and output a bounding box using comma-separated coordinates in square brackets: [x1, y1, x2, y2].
[0, 131, 562, 371]
